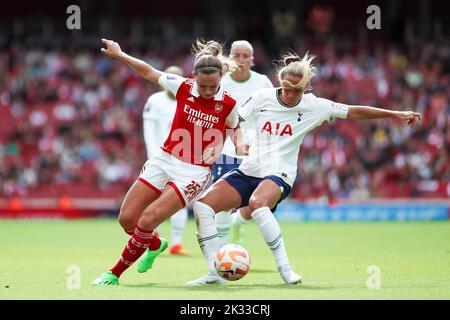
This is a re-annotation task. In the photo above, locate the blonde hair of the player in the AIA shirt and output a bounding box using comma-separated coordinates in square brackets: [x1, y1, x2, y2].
[278, 52, 316, 89]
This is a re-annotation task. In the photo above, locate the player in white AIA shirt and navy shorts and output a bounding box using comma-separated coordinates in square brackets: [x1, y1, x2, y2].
[190, 54, 421, 285]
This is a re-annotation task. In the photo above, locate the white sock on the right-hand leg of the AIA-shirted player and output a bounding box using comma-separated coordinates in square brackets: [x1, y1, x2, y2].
[252, 207, 289, 269]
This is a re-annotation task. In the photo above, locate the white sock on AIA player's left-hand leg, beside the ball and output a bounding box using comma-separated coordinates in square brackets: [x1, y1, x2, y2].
[193, 201, 219, 274]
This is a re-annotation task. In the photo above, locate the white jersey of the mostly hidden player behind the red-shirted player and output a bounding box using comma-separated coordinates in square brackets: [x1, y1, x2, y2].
[142, 91, 177, 159]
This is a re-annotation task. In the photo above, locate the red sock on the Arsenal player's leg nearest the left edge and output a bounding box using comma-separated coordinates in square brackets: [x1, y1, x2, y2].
[110, 227, 153, 277]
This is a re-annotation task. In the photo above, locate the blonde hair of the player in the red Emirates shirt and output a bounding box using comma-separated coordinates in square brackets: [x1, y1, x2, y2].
[192, 39, 237, 75]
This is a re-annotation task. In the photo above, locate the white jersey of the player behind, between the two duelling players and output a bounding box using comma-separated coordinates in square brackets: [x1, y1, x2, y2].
[221, 71, 273, 159]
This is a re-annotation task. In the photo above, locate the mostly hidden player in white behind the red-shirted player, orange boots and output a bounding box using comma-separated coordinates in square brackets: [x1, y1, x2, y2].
[142, 66, 189, 255]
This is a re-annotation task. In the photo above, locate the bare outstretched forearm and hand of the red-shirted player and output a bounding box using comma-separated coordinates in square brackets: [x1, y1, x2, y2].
[101, 39, 162, 84]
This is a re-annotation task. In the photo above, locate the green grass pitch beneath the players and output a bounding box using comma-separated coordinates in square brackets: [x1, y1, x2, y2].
[0, 219, 450, 300]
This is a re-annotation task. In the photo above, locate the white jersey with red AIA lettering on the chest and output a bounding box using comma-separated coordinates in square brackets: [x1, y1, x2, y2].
[238, 88, 348, 186]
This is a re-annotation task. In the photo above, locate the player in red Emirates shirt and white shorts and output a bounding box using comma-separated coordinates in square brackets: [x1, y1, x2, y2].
[92, 39, 243, 285]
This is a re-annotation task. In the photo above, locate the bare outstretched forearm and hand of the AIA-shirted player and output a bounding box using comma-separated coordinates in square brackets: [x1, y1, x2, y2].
[347, 106, 421, 125]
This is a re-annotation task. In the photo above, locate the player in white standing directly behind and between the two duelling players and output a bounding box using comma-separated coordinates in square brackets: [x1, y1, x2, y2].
[213, 40, 273, 246]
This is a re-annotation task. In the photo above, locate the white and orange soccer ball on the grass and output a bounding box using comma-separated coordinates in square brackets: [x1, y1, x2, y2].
[214, 244, 250, 281]
